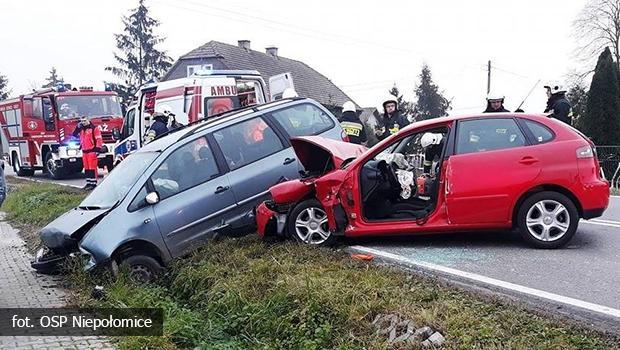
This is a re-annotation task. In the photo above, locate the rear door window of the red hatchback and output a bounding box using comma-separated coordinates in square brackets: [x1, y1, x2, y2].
[456, 118, 526, 154]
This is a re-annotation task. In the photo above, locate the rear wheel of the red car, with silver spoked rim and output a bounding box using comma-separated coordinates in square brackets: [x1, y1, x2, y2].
[517, 191, 579, 249]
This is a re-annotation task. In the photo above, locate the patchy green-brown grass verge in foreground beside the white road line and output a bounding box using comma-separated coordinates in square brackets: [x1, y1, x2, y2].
[4, 179, 619, 349]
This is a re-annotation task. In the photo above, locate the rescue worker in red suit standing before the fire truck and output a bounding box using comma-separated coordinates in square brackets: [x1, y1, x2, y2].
[73, 117, 103, 190]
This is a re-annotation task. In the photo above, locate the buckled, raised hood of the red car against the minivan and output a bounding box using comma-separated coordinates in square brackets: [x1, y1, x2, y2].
[291, 136, 367, 175]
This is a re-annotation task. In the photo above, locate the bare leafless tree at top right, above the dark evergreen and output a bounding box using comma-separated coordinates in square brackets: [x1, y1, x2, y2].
[573, 0, 620, 75]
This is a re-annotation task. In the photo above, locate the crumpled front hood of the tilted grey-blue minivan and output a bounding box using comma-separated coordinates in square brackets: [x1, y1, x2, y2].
[39, 208, 110, 250]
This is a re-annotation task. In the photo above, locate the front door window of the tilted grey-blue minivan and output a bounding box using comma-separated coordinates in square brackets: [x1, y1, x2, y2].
[151, 137, 220, 199]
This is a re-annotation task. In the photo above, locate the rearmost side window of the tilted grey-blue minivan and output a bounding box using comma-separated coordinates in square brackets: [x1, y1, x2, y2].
[271, 103, 334, 137]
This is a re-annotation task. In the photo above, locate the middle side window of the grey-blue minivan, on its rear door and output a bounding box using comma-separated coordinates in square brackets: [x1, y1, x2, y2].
[213, 117, 284, 170]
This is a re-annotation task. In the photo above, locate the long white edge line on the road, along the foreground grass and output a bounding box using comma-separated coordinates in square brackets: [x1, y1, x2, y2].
[350, 245, 620, 318]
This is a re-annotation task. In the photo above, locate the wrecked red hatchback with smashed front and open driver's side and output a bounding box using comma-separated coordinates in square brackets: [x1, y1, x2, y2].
[256, 113, 610, 248]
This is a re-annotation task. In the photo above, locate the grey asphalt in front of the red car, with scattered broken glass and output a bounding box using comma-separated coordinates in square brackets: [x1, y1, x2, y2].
[348, 197, 620, 329]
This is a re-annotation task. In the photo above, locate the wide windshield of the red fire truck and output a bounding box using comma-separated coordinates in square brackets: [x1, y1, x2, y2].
[56, 95, 122, 119]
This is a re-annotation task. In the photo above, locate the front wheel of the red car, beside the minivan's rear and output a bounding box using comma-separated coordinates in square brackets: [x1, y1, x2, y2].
[287, 198, 337, 246]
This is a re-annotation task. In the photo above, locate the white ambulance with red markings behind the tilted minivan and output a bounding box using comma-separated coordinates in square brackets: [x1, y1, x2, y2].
[114, 70, 293, 164]
